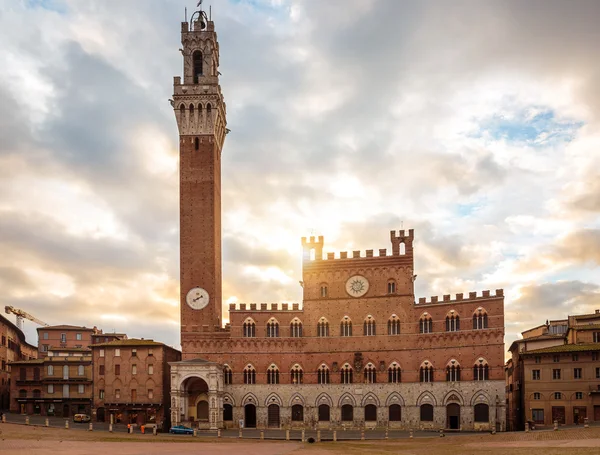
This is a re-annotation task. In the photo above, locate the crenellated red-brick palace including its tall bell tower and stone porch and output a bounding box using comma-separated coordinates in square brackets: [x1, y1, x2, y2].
[170, 11, 505, 430]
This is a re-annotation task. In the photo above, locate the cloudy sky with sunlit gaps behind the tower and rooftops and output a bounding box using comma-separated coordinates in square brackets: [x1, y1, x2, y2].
[0, 0, 600, 347]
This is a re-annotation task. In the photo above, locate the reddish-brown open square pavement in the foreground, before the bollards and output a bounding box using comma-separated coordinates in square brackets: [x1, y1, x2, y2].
[0, 424, 600, 455]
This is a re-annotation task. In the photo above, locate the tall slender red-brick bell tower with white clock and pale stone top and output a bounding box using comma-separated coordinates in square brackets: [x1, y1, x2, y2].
[171, 4, 227, 353]
